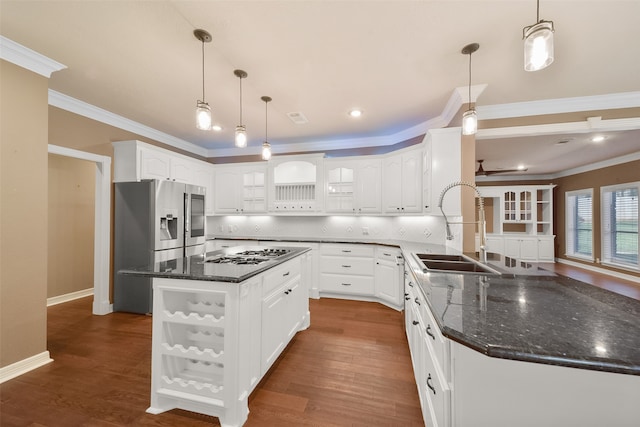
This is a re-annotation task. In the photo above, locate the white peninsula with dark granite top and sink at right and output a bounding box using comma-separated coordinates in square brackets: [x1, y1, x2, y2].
[405, 249, 640, 427]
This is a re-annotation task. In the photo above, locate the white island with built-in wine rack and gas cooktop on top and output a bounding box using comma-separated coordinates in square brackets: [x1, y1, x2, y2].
[120, 246, 310, 427]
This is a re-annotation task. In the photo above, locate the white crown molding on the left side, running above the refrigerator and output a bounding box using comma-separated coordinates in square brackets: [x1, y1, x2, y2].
[49, 89, 208, 157]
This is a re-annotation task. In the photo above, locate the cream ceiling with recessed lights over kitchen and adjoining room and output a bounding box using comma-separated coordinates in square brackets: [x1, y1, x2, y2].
[0, 0, 640, 173]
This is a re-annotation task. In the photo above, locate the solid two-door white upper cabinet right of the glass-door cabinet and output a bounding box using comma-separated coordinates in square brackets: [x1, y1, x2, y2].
[382, 149, 423, 213]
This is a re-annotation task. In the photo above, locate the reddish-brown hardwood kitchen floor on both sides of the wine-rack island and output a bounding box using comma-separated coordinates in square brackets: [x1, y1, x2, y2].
[0, 297, 423, 427]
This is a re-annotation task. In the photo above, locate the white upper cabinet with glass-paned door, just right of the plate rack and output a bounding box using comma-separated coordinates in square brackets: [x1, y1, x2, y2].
[324, 158, 382, 213]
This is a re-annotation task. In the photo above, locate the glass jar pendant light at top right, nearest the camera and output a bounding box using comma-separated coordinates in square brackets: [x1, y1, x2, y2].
[522, 0, 555, 71]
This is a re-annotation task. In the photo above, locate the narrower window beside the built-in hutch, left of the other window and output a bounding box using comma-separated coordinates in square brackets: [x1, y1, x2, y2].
[565, 189, 593, 260]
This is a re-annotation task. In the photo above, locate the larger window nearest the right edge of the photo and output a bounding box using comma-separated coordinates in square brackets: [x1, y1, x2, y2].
[602, 182, 640, 269]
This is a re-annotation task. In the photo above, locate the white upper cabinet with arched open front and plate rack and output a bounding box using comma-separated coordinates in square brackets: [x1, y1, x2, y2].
[268, 155, 324, 212]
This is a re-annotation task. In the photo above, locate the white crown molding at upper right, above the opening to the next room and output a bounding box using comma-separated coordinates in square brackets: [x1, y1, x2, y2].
[476, 92, 640, 120]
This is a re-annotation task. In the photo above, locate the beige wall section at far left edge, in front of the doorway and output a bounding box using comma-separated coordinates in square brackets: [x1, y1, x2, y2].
[0, 60, 48, 367]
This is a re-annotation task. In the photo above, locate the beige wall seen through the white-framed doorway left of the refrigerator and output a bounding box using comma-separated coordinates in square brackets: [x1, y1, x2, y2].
[47, 154, 96, 298]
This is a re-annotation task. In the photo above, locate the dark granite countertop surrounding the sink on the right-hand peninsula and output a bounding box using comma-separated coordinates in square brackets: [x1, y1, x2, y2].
[408, 256, 640, 375]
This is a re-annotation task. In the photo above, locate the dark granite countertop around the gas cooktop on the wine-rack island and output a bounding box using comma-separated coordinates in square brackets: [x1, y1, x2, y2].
[118, 246, 310, 283]
